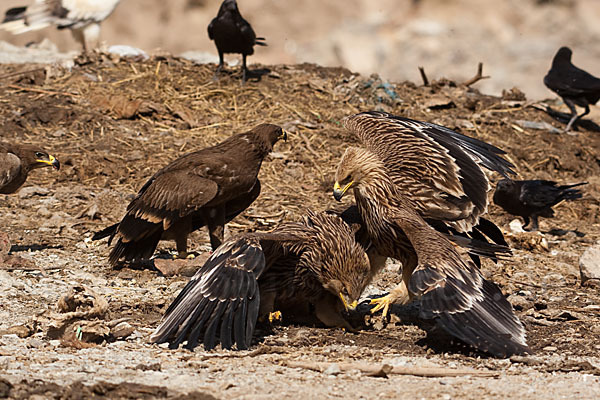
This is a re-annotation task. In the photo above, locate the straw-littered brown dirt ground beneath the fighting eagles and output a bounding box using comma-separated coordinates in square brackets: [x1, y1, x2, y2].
[0, 56, 600, 399]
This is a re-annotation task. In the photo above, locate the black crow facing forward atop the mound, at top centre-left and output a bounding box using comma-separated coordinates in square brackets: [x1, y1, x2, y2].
[208, 0, 267, 82]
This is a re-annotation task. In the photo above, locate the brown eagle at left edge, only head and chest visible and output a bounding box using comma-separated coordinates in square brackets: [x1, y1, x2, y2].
[0, 142, 60, 194]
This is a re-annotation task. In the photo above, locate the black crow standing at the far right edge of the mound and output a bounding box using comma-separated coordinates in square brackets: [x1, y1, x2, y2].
[544, 47, 600, 132]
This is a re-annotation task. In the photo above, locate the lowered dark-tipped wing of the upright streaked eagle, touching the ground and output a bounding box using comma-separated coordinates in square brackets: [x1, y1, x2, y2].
[408, 222, 530, 357]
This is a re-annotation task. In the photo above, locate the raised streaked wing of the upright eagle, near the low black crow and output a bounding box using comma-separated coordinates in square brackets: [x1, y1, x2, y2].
[344, 112, 512, 231]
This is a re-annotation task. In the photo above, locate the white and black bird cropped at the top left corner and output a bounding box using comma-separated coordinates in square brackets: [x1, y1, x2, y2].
[0, 0, 120, 51]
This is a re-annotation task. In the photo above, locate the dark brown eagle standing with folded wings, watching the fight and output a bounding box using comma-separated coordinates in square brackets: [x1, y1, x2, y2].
[92, 124, 287, 266]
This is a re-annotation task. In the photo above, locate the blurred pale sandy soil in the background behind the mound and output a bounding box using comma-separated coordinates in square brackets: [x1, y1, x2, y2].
[0, 0, 600, 99]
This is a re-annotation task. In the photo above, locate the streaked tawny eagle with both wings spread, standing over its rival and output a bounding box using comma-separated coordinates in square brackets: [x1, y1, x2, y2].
[334, 112, 529, 356]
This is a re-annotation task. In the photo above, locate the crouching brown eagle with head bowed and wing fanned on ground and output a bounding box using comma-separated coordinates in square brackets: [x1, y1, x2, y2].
[151, 211, 370, 350]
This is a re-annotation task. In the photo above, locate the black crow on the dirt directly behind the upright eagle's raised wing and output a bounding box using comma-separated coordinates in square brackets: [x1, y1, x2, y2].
[494, 179, 587, 231]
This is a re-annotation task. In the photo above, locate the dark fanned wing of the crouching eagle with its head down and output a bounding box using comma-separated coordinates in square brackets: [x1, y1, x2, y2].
[151, 236, 265, 350]
